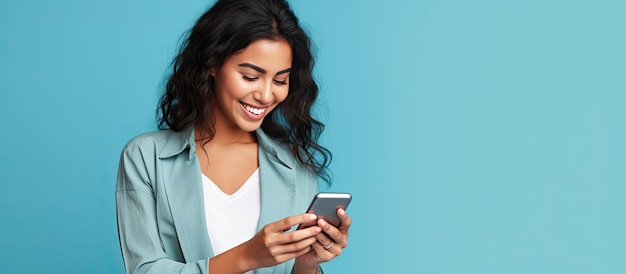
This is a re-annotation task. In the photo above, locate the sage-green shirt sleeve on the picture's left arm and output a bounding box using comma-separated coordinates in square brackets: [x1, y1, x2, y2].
[115, 142, 208, 274]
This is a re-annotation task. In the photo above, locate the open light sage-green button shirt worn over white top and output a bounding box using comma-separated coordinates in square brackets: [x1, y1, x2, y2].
[115, 127, 317, 274]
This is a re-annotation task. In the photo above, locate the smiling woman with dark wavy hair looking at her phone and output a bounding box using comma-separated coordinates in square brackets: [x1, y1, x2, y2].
[116, 0, 351, 274]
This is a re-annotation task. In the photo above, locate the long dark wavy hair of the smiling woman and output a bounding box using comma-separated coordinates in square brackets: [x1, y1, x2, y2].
[157, 0, 332, 183]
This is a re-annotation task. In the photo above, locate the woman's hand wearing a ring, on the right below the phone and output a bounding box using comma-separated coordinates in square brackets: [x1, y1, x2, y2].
[294, 208, 352, 273]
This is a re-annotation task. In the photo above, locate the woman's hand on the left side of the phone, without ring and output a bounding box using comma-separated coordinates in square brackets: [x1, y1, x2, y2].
[240, 213, 322, 269]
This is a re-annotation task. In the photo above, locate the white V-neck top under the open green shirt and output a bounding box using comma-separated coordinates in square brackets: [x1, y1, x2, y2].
[202, 168, 261, 274]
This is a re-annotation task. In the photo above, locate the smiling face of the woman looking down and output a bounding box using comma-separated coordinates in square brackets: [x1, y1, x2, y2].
[211, 39, 292, 132]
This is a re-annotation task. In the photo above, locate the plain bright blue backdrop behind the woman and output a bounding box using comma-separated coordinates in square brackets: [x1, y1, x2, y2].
[0, 0, 626, 274]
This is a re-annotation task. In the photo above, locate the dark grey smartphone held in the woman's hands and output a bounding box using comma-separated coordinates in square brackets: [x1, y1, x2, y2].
[298, 192, 352, 229]
